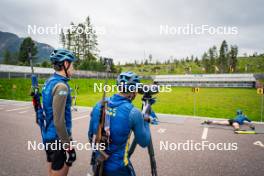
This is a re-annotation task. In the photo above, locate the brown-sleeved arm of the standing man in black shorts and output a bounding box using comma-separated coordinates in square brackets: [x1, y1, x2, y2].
[52, 83, 70, 144]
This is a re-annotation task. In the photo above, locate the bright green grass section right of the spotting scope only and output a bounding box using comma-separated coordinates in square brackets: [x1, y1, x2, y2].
[155, 88, 260, 120]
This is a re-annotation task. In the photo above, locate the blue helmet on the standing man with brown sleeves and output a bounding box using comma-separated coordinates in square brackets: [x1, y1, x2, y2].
[50, 48, 76, 63]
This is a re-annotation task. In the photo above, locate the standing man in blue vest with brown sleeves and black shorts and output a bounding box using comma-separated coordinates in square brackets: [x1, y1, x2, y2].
[42, 49, 76, 176]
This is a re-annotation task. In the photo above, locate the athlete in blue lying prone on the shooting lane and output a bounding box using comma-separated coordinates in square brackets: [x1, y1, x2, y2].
[202, 109, 255, 131]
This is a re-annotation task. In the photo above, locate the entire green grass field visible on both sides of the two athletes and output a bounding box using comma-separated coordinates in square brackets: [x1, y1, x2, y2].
[0, 79, 261, 120]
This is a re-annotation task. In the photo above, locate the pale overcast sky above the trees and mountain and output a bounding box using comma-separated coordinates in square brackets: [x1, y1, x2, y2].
[0, 0, 264, 63]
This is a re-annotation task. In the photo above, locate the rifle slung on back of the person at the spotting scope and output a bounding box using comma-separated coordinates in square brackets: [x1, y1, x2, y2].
[91, 58, 113, 176]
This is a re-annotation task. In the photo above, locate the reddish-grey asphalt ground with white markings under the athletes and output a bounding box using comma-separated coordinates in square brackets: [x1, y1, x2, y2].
[0, 100, 264, 176]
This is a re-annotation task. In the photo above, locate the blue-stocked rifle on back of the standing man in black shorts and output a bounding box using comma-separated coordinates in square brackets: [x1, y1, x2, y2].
[28, 48, 45, 137]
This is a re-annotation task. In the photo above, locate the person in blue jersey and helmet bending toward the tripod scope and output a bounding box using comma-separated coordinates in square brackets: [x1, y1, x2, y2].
[88, 72, 150, 176]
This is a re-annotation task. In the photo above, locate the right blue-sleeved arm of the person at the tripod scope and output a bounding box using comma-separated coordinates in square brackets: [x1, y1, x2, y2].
[129, 108, 150, 147]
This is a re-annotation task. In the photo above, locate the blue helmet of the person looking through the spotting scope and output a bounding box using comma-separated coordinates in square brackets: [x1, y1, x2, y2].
[116, 71, 140, 91]
